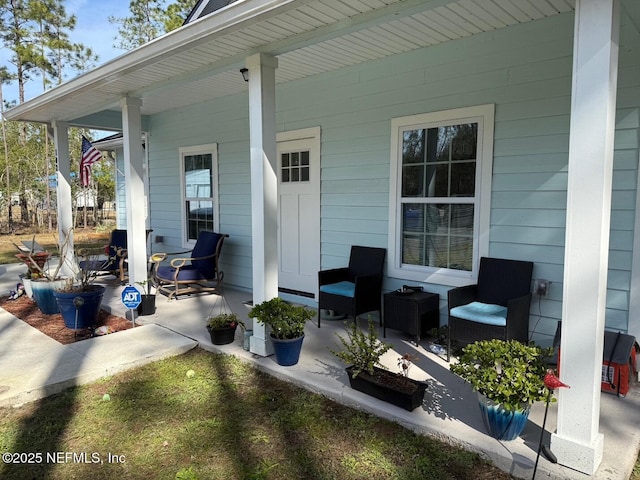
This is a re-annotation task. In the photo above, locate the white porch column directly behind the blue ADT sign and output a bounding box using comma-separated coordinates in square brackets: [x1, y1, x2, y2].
[120, 97, 147, 288]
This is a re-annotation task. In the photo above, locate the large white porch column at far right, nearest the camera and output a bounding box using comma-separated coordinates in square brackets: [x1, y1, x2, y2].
[551, 0, 619, 475]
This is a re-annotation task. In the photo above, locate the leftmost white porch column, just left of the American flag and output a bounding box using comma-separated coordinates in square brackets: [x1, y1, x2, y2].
[53, 122, 76, 277]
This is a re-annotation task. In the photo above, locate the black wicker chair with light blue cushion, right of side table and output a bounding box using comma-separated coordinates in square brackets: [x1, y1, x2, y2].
[447, 257, 533, 360]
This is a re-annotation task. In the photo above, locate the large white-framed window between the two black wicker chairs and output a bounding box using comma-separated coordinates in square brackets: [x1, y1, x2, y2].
[389, 105, 494, 285]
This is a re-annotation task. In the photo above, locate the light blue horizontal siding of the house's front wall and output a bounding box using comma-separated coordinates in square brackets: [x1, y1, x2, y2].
[149, 10, 640, 344]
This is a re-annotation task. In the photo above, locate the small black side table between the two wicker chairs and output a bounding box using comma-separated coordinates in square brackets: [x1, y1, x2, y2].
[382, 292, 440, 343]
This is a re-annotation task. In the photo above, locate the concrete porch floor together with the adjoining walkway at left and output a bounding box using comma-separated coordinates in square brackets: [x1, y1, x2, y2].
[0, 265, 640, 480]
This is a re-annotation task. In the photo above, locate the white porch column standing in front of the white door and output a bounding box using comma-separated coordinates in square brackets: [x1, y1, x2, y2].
[245, 53, 278, 356]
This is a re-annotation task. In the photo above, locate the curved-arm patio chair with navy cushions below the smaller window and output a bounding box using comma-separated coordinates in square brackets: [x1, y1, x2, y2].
[150, 231, 229, 300]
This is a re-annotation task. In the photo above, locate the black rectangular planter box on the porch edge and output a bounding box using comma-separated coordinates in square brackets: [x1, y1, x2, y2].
[346, 367, 427, 412]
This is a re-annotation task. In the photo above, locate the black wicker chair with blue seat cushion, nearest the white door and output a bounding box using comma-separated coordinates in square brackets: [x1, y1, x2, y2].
[318, 245, 387, 328]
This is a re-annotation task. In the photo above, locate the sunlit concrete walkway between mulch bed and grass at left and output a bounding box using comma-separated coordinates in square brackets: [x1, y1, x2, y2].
[0, 265, 198, 406]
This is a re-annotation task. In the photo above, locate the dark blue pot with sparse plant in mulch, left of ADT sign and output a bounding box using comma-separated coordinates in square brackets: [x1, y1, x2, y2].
[53, 249, 106, 330]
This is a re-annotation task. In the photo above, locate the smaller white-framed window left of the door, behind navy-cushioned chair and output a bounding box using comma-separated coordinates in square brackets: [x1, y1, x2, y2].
[180, 144, 218, 243]
